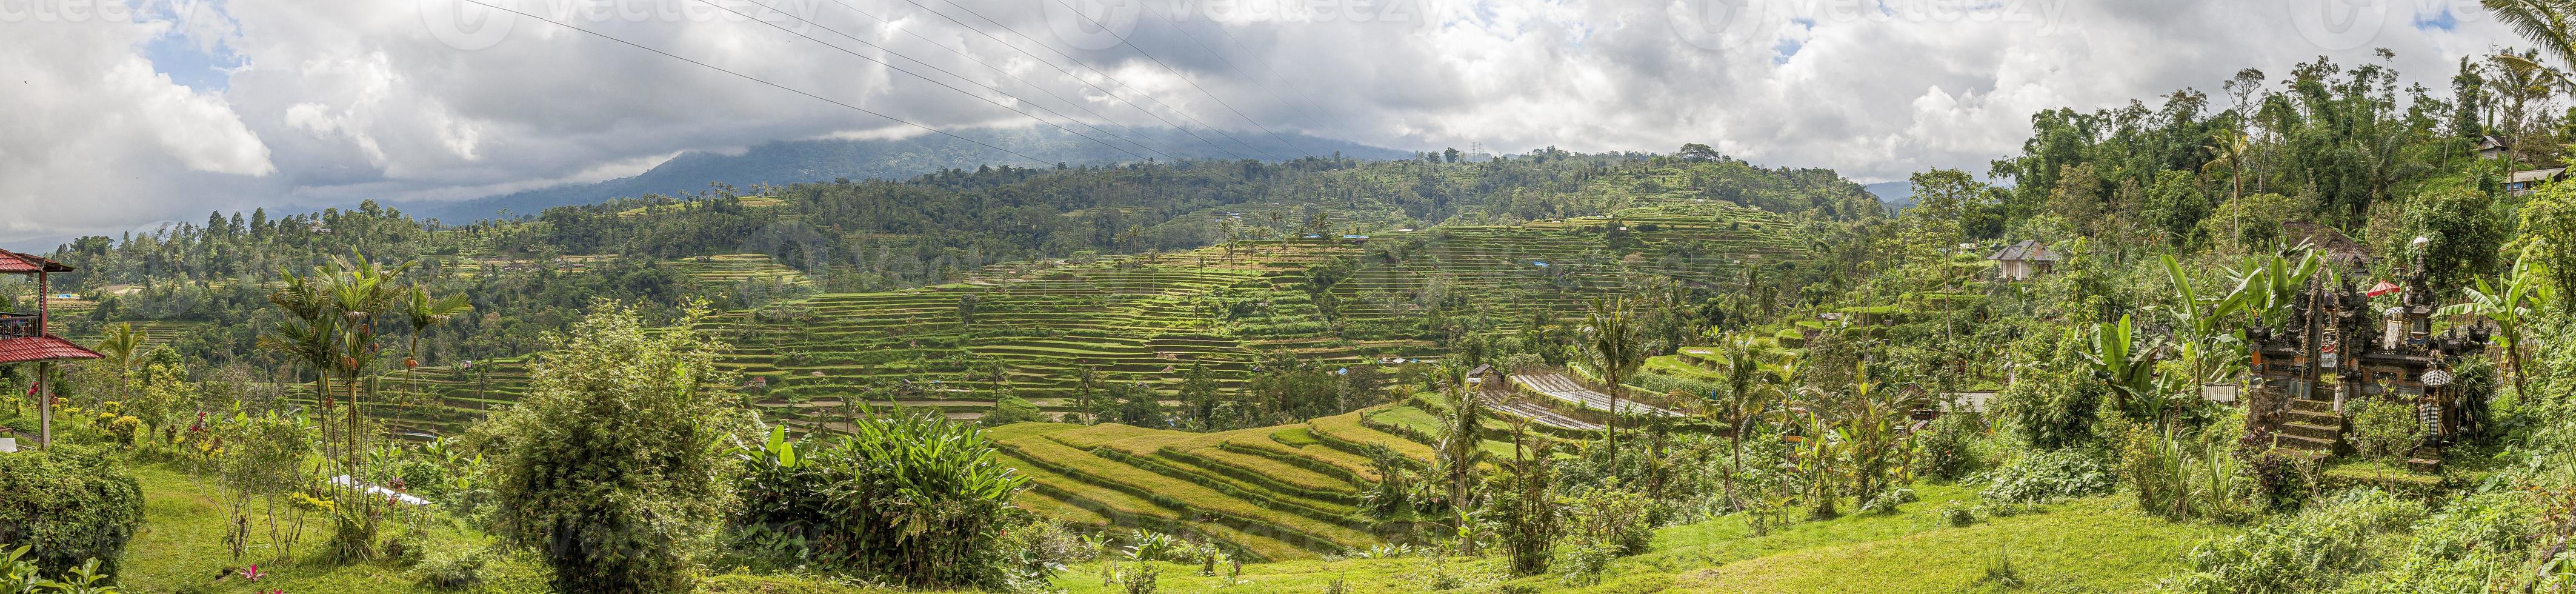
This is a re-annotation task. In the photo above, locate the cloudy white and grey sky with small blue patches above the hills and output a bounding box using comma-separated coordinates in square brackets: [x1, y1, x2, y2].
[0, 0, 2517, 242]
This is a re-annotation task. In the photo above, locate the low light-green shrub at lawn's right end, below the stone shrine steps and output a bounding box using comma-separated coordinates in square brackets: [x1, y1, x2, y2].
[2174, 491, 2424, 594]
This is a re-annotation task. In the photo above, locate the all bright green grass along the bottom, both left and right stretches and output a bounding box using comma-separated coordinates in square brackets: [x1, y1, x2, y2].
[124, 466, 2228, 594]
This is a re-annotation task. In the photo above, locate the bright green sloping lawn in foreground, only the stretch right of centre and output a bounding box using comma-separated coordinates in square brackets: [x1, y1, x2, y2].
[1056, 486, 2228, 594]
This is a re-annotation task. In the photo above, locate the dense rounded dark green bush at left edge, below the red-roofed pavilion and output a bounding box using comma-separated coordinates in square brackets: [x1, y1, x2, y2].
[0, 445, 144, 576]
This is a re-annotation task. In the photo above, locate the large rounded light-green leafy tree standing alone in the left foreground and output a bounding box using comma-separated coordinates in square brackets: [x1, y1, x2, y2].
[474, 304, 742, 594]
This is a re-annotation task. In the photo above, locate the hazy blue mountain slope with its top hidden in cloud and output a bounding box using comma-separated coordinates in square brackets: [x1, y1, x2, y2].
[402, 128, 1414, 221]
